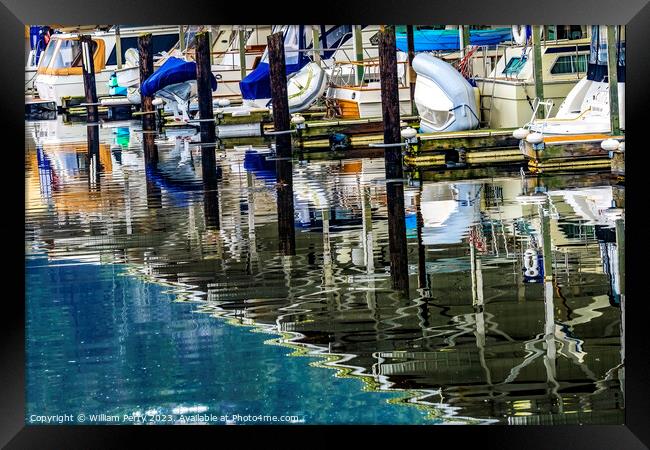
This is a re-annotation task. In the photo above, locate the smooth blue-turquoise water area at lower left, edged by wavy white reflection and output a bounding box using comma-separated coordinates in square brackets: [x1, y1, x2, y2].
[26, 256, 436, 424]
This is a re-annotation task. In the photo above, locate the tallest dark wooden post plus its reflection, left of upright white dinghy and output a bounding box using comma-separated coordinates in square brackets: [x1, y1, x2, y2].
[379, 25, 409, 291]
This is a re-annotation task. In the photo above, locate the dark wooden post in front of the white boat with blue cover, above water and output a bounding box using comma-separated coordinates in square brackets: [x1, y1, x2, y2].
[266, 32, 291, 157]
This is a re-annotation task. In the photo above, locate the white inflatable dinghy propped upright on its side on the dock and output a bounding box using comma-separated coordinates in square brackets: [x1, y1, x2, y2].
[413, 53, 479, 133]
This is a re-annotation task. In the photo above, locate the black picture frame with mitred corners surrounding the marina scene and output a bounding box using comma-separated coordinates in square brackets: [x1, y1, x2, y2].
[5, 0, 650, 450]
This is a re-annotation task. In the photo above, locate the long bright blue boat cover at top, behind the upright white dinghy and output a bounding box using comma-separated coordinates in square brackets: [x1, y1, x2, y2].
[395, 28, 512, 52]
